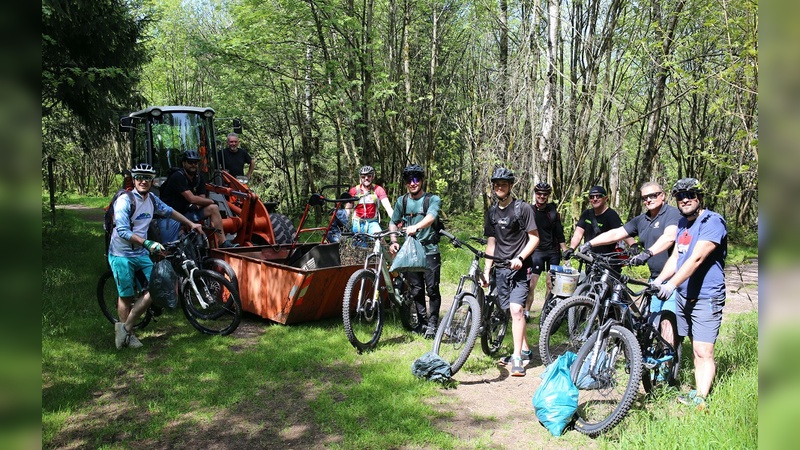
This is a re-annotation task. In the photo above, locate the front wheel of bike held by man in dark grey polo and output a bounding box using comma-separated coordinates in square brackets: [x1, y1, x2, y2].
[433, 293, 481, 376]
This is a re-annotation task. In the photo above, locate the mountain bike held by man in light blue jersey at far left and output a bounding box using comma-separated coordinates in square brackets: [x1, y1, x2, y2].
[97, 231, 242, 335]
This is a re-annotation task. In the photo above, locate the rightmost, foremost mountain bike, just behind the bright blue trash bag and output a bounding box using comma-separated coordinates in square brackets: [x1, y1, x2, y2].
[570, 252, 681, 437]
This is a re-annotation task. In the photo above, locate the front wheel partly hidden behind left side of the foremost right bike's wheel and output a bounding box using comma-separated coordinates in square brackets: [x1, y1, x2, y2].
[539, 295, 600, 365]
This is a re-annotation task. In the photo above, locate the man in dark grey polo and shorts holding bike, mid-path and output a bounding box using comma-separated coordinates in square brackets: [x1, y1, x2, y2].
[483, 167, 539, 377]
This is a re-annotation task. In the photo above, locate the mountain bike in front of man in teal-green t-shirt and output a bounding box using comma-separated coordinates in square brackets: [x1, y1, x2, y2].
[342, 231, 419, 353]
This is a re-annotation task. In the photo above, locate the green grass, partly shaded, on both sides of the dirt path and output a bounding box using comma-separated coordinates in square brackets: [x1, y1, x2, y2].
[41, 202, 758, 449]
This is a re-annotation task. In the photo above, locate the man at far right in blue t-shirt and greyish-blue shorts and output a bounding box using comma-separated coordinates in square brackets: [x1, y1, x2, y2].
[652, 178, 728, 410]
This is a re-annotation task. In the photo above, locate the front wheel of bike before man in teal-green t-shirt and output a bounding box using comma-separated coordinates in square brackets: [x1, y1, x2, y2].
[342, 269, 384, 353]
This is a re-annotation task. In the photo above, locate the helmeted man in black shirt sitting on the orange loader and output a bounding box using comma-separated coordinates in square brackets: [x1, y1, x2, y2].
[158, 150, 232, 247]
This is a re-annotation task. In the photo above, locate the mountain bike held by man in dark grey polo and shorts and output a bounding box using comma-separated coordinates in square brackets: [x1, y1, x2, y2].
[433, 230, 511, 375]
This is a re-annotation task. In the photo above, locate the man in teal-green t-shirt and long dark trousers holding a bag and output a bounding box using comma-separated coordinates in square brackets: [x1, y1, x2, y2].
[389, 164, 442, 339]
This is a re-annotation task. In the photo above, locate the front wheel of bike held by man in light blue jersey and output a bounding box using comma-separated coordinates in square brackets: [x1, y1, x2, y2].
[180, 269, 242, 336]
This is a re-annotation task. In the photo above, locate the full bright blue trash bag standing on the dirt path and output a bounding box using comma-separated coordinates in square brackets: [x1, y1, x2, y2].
[533, 352, 578, 436]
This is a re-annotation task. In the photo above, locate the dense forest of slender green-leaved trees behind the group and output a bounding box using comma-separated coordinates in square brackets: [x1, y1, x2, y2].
[42, 0, 758, 235]
